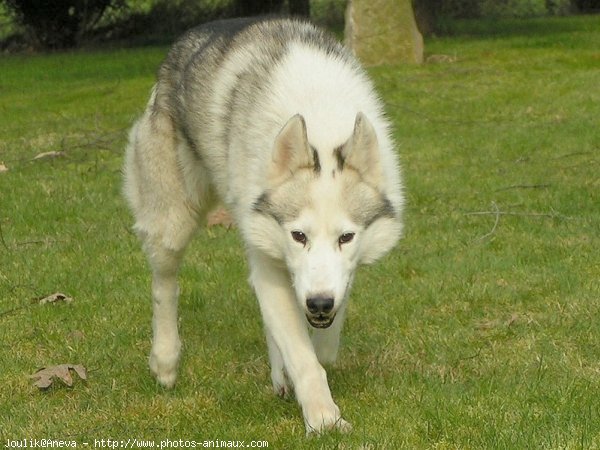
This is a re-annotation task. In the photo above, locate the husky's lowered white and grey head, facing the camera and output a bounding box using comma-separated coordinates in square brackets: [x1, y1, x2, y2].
[251, 113, 401, 328]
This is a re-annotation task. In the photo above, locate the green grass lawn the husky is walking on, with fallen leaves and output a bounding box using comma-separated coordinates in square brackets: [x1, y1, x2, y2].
[0, 17, 600, 449]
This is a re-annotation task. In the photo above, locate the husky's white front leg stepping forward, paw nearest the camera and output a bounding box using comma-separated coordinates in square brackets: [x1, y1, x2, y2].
[250, 251, 351, 433]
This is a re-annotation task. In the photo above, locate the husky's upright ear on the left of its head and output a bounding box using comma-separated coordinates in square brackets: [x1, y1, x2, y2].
[269, 114, 316, 183]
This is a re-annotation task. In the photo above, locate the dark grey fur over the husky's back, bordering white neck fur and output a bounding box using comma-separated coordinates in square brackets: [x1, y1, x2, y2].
[155, 18, 360, 164]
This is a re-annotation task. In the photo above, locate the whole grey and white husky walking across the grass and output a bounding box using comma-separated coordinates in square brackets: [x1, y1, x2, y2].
[124, 19, 402, 432]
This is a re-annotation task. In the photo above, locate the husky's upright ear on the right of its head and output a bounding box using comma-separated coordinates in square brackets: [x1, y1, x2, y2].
[339, 112, 383, 187]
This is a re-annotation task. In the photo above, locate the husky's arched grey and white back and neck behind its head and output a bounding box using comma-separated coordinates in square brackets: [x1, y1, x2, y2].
[147, 19, 396, 219]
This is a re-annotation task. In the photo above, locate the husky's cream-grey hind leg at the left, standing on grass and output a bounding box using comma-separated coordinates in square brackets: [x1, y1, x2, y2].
[124, 95, 200, 387]
